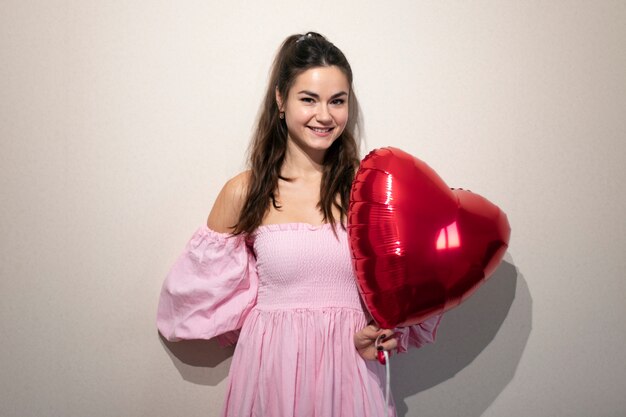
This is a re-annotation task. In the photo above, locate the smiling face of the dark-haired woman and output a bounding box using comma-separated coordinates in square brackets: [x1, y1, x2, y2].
[276, 66, 350, 158]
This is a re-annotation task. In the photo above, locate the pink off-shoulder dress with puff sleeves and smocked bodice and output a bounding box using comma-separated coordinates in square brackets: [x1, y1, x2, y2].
[157, 223, 440, 417]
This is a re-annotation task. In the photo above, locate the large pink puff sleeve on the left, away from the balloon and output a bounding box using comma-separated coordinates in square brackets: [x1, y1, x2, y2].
[157, 226, 258, 345]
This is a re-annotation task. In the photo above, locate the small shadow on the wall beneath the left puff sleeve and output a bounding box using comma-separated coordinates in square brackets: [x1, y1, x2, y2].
[159, 335, 235, 386]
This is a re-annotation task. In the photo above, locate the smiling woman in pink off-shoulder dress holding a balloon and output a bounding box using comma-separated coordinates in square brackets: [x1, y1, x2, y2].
[157, 32, 439, 416]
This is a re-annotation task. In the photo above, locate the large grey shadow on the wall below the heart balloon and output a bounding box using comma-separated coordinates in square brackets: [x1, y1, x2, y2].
[391, 255, 532, 417]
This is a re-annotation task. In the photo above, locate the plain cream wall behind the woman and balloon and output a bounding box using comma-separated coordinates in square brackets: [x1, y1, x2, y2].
[0, 0, 626, 417]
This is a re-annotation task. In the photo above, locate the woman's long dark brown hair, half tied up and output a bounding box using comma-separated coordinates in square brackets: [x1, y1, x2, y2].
[234, 32, 359, 234]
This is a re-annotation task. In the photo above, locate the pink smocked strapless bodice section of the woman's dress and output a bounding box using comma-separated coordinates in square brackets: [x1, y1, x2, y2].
[253, 223, 362, 310]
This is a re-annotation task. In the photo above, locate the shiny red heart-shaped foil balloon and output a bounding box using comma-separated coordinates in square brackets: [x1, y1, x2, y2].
[348, 148, 511, 328]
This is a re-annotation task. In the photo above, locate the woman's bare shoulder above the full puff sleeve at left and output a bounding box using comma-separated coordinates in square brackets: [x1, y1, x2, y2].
[207, 171, 250, 233]
